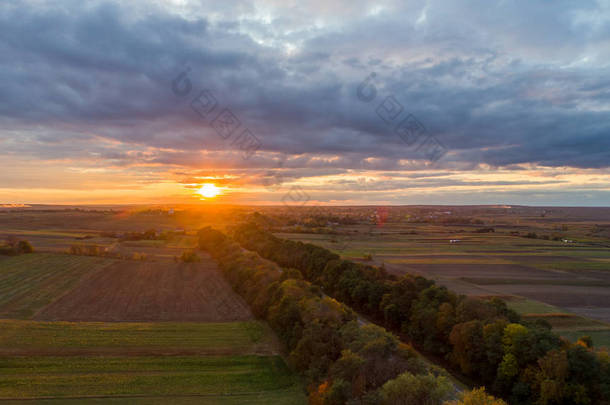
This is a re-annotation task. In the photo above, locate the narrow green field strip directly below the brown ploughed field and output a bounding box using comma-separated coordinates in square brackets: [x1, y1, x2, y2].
[0, 320, 277, 355]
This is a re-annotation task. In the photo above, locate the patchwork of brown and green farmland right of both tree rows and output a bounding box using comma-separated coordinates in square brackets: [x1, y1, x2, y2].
[276, 208, 610, 345]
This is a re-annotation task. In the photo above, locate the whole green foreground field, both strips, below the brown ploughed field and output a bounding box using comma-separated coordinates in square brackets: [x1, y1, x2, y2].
[0, 320, 306, 405]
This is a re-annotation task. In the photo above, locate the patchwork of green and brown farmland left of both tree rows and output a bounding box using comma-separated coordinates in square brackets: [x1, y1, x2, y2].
[0, 213, 306, 405]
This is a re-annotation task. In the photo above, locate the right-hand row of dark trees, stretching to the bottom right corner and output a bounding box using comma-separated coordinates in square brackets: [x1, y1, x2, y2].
[233, 223, 610, 405]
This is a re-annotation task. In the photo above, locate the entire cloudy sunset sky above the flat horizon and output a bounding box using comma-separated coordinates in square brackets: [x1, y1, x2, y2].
[0, 0, 610, 206]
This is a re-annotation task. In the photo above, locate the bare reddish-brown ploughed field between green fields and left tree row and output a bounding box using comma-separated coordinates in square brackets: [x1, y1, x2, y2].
[35, 257, 252, 322]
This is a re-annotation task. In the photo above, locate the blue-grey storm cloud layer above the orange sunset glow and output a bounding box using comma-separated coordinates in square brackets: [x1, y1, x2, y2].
[0, 1, 610, 172]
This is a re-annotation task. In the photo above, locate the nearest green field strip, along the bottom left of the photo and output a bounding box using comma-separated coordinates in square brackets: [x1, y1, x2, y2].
[0, 356, 299, 398]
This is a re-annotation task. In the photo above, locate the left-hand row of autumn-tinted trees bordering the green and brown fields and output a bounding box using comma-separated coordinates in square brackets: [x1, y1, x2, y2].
[199, 228, 468, 405]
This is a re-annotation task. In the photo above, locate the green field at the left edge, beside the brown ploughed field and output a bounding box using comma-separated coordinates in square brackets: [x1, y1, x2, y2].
[0, 253, 113, 319]
